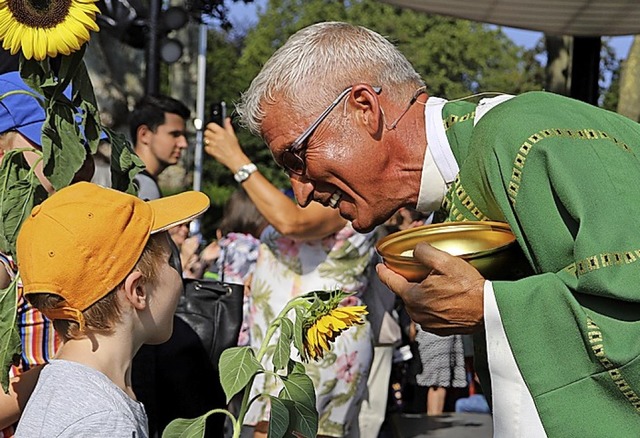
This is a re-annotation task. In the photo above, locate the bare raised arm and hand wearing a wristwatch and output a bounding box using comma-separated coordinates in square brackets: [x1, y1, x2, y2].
[204, 118, 346, 240]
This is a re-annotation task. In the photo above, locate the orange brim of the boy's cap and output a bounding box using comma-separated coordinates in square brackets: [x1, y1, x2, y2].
[147, 191, 209, 234]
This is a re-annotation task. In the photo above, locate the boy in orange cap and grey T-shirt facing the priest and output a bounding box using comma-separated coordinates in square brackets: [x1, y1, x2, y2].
[16, 182, 209, 438]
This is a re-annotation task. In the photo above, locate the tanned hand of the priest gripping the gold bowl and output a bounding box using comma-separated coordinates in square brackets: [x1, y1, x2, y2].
[376, 243, 485, 336]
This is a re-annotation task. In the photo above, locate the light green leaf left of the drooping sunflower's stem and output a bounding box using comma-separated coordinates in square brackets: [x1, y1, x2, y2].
[219, 347, 263, 403]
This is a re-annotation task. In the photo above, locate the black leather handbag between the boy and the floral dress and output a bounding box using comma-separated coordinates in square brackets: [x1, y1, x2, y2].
[176, 279, 244, 370]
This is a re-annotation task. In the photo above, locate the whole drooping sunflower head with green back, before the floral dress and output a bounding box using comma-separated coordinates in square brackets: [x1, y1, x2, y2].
[301, 291, 368, 361]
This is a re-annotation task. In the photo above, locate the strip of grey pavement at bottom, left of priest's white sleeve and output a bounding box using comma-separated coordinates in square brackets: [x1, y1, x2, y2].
[382, 413, 493, 438]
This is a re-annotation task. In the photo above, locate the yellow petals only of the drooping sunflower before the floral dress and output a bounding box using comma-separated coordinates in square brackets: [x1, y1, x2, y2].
[303, 306, 368, 360]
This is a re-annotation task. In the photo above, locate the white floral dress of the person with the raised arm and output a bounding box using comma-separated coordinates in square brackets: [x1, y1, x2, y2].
[245, 224, 376, 437]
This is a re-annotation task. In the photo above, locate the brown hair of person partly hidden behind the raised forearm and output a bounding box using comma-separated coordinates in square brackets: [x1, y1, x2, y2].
[219, 189, 267, 238]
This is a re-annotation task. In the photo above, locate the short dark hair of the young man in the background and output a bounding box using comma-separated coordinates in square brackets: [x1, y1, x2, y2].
[129, 94, 191, 144]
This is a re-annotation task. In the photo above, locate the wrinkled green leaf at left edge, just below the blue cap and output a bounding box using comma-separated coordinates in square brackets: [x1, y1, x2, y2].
[0, 149, 47, 257]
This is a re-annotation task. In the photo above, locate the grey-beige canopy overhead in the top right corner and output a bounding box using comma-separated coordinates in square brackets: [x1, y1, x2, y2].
[383, 0, 640, 36]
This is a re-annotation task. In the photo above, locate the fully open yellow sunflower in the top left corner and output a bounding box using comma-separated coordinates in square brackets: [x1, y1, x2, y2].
[0, 0, 100, 61]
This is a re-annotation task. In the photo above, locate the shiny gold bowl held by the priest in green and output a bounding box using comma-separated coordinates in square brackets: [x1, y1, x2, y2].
[376, 221, 531, 281]
